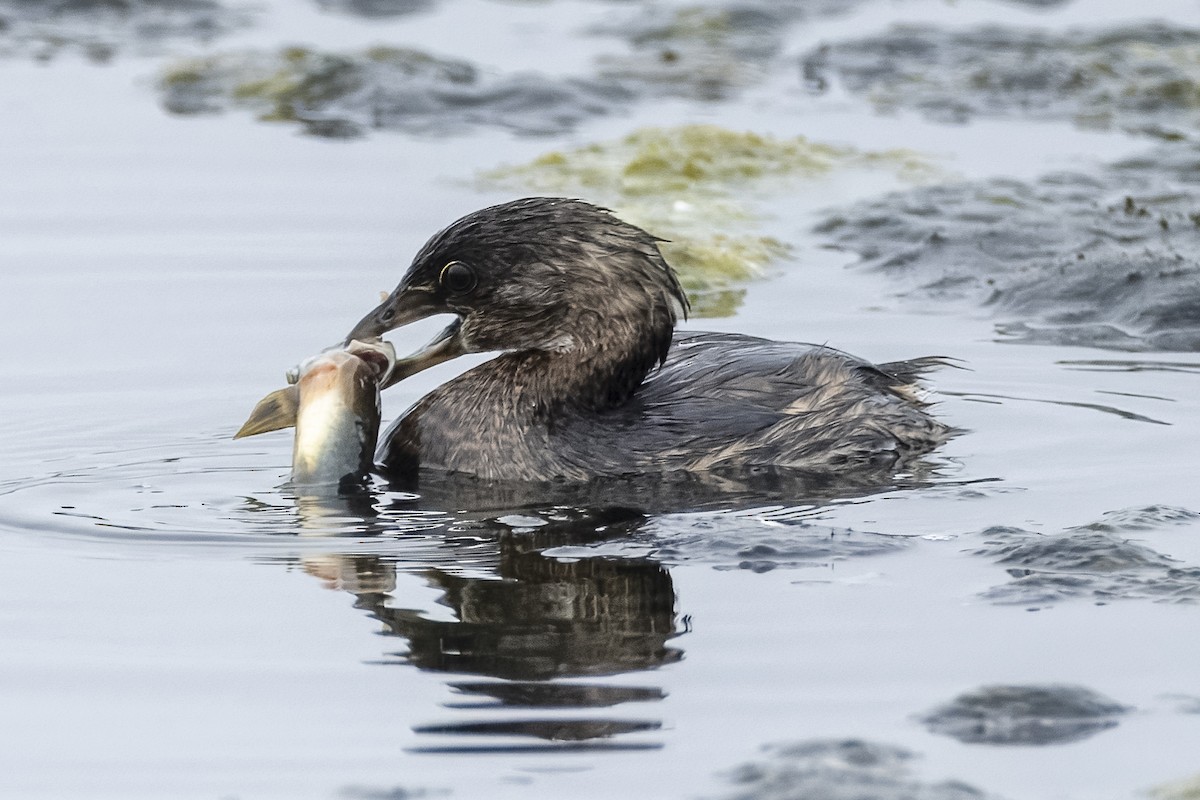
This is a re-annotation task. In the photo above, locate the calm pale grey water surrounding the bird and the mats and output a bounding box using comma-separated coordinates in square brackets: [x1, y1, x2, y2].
[0, 0, 1200, 800]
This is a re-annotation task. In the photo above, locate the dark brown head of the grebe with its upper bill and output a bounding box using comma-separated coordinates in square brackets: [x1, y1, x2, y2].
[347, 197, 688, 374]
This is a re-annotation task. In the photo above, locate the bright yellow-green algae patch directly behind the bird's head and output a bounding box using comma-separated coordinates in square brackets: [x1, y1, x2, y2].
[482, 125, 931, 317]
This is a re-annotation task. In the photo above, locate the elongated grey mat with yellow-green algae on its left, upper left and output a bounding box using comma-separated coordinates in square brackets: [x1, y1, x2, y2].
[158, 47, 630, 138]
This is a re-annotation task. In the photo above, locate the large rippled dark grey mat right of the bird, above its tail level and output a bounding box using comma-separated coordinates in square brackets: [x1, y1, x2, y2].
[817, 145, 1200, 351]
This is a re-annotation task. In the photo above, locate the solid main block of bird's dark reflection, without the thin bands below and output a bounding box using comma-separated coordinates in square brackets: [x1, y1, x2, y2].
[358, 515, 682, 681]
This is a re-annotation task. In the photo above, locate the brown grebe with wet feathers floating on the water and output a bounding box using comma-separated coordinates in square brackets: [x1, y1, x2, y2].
[349, 198, 950, 480]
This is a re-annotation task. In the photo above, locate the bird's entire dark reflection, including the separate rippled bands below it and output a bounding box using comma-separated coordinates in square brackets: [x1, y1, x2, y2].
[300, 515, 683, 752]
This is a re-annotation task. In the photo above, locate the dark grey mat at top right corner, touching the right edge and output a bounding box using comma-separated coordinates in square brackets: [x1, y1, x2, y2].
[802, 23, 1200, 139]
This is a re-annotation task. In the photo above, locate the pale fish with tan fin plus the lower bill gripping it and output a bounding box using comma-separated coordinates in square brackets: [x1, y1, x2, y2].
[234, 323, 461, 488]
